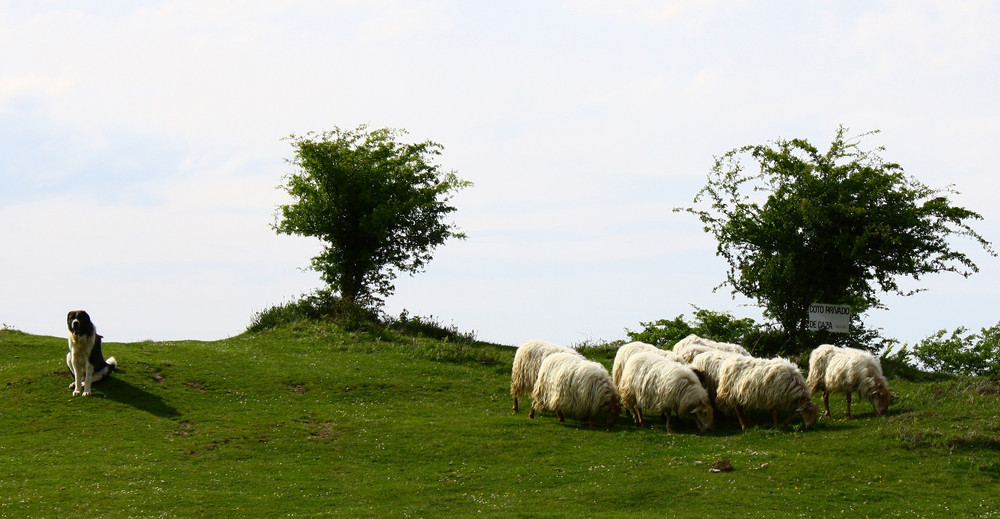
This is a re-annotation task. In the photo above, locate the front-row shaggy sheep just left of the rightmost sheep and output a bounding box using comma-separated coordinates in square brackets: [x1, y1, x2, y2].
[716, 356, 819, 430]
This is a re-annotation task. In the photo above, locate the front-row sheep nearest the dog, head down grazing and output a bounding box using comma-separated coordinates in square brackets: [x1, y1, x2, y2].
[528, 352, 621, 427]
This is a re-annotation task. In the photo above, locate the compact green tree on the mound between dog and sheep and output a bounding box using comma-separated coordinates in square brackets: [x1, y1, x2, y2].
[274, 125, 472, 307]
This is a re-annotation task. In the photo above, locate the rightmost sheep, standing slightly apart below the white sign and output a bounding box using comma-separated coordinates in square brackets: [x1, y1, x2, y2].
[806, 344, 891, 420]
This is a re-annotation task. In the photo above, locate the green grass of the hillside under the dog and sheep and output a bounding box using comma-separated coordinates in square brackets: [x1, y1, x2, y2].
[0, 328, 1000, 518]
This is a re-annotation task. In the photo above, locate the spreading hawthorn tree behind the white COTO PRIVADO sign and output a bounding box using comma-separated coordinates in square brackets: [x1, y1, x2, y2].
[675, 126, 996, 348]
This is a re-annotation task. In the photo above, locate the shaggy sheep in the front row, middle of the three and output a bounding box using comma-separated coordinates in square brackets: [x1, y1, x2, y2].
[618, 352, 715, 432]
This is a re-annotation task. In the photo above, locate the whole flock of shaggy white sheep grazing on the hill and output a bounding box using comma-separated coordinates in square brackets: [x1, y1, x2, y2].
[510, 335, 890, 432]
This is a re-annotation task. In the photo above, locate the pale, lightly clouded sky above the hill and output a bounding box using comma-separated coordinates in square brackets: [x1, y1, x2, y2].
[0, 0, 1000, 345]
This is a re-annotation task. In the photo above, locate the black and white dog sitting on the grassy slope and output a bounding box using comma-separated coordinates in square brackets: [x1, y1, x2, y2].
[66, 310, 118, 396]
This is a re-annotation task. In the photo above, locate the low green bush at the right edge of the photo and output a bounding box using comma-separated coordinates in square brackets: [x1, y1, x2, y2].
[912, 323, 1000, 378]
